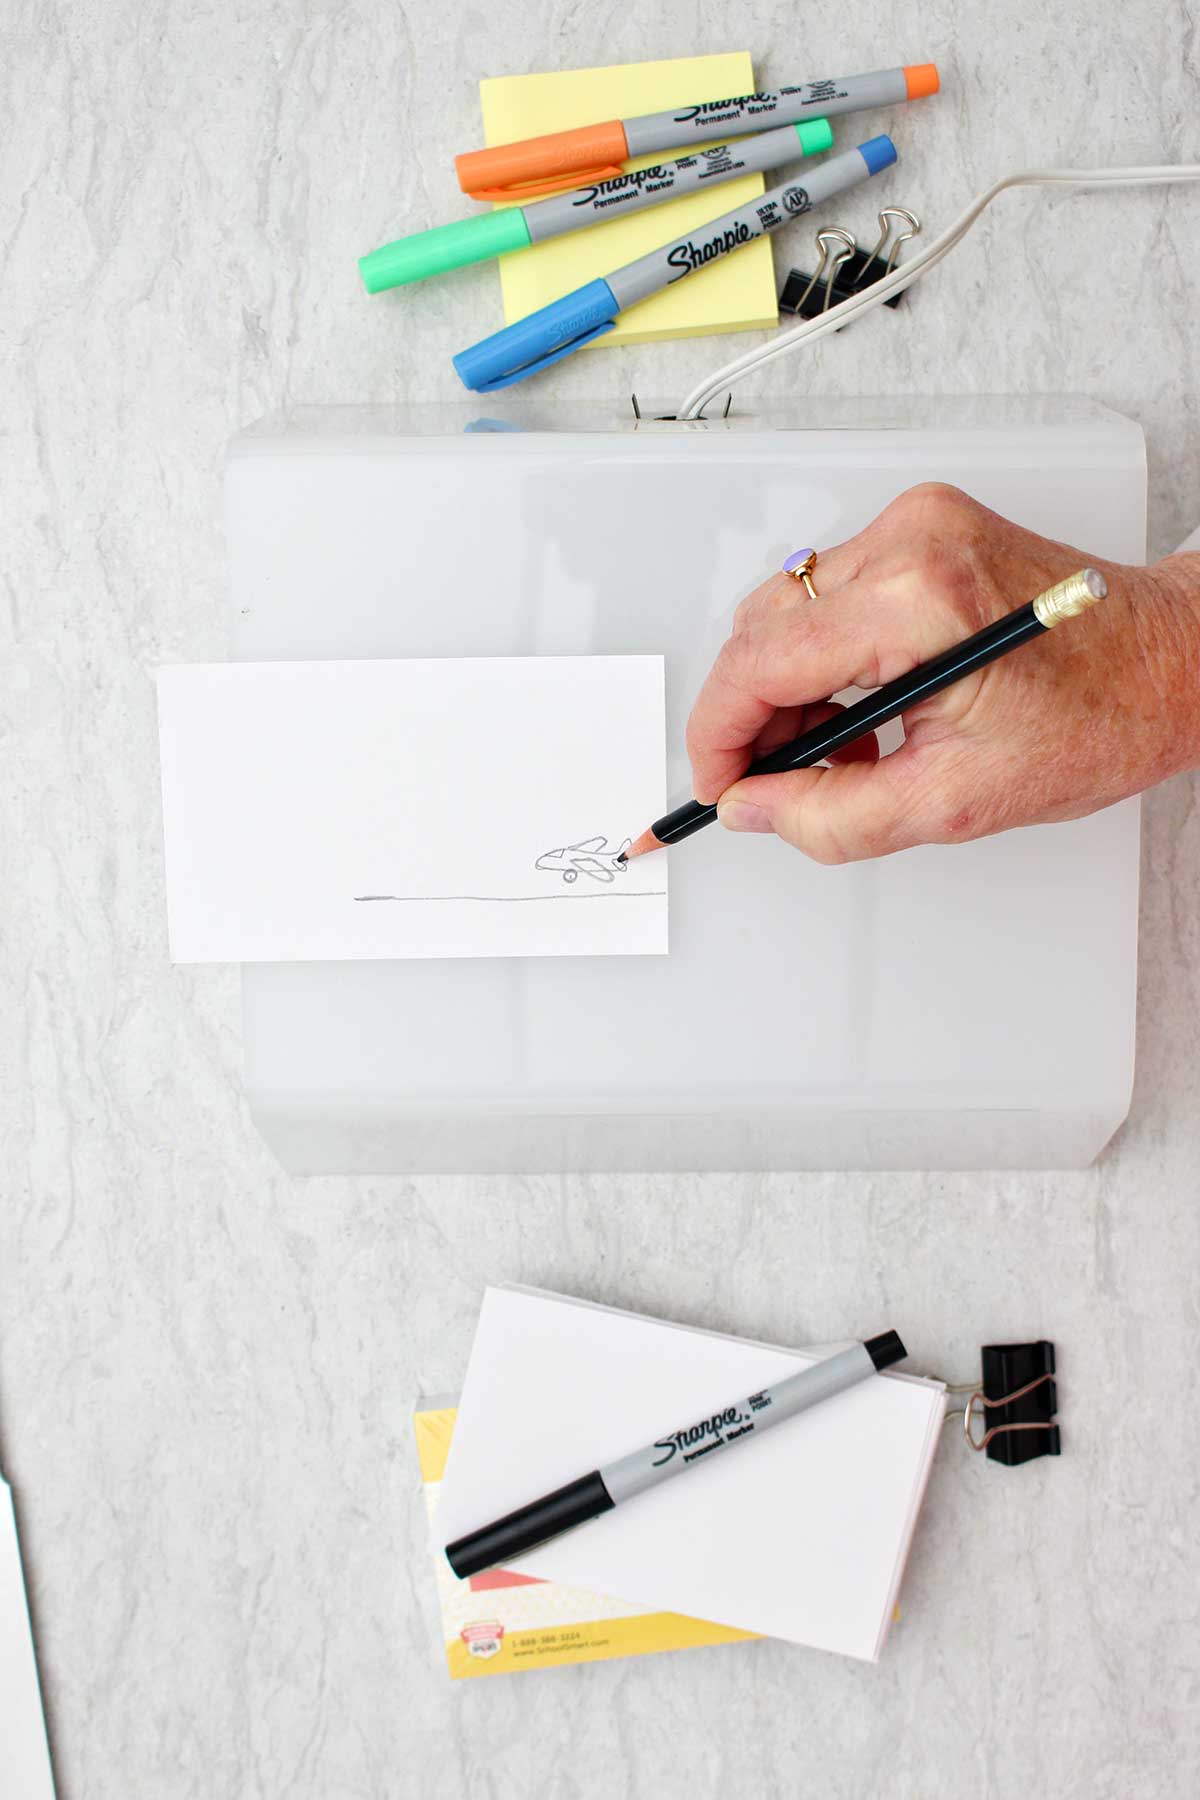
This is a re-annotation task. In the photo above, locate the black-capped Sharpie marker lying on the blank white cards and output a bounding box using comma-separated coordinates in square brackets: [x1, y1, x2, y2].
[446, 1332, 909, 1580]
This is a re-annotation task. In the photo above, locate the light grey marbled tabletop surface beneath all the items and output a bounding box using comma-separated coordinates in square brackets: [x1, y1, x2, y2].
[0, 0, 1200, 1800]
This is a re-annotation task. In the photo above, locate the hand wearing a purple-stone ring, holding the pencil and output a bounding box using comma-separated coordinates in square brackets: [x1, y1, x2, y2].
[687, 486, 1200, 862]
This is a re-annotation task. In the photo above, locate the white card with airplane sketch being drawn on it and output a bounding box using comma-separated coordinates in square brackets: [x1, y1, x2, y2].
[158, 655, 667, 963]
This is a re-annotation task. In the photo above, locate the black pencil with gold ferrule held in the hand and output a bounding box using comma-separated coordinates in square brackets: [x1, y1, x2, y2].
[622, 569, 1108, 862]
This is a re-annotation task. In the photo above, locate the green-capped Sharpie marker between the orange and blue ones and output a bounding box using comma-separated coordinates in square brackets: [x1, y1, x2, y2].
[358, 119, 833, 293]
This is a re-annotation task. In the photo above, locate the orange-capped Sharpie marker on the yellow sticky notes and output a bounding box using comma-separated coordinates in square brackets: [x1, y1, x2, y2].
[453, 63, 937, 200]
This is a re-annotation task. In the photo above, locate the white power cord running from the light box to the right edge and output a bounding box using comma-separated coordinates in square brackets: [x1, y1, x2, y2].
[678, 162, 1200, 419]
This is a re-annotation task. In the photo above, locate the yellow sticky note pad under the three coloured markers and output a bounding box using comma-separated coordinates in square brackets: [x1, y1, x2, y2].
[479, 50, 779, 349]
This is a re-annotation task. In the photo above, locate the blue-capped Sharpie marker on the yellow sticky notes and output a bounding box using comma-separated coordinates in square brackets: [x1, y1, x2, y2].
[453, 137, 898, 394]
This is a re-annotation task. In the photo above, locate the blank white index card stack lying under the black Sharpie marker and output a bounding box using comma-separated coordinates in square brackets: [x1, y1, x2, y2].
[435, 1287, 945, 1661]
